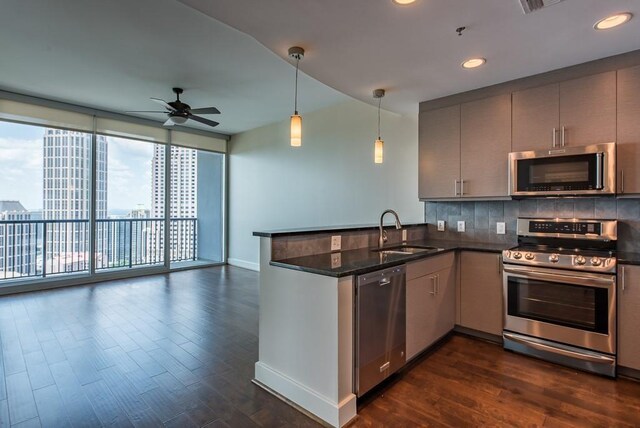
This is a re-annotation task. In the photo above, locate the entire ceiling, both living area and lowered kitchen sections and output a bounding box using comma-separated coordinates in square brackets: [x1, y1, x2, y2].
[0, 0, 640, 134]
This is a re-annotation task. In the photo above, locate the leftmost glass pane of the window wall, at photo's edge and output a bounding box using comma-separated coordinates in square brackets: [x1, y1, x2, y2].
[0, 122, 91, 279]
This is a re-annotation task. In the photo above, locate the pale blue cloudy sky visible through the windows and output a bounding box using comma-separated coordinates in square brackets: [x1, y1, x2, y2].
[0, 121, 153, 212]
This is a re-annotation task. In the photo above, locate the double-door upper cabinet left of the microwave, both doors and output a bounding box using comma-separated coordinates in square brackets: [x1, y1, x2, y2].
[418, 94, 511, 199]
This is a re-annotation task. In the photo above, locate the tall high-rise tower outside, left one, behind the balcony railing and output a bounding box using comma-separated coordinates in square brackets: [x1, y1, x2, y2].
[42, 129, 107, 273]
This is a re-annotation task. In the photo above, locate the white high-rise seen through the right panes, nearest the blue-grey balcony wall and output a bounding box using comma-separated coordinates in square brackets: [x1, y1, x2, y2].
[151, 145, 198, 261]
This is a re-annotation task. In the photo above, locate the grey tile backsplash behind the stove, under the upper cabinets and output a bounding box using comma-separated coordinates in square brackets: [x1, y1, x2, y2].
[425, 198, 640, 252]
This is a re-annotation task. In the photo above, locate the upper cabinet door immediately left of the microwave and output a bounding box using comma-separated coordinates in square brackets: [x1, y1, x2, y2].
[459, 94, 511, 198]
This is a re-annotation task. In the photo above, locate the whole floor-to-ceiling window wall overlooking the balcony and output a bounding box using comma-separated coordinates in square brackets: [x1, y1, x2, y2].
[0, 97, 226, 287]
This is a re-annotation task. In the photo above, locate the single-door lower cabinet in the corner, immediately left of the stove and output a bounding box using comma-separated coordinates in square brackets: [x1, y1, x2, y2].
[460, 251, 504, 336]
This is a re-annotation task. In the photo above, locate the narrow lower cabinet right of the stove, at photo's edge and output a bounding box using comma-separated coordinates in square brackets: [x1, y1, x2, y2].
[618, 265, 640, 370]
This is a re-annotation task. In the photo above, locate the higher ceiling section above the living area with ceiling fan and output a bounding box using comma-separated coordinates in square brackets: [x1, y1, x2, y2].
[0, 0, 348, 134]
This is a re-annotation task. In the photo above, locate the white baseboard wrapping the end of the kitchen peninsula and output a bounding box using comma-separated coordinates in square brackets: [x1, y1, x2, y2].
[255, 361, 356, 427]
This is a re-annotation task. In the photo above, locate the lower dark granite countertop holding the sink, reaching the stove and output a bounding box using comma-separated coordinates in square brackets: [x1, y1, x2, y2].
[270, 239, 514, 277]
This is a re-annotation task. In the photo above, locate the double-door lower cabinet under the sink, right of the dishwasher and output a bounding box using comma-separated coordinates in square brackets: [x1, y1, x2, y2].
[406, 252, 456, 361]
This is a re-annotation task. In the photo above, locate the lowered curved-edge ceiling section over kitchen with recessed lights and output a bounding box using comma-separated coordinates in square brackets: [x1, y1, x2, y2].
[180, 0, 640, 112]
